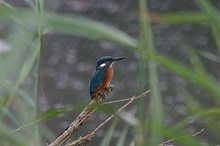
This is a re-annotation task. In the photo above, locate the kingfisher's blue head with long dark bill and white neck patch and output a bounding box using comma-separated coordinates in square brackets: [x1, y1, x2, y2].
[96, 56, 126, 69]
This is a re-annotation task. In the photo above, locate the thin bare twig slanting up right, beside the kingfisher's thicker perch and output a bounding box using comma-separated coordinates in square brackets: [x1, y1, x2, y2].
[67, 90, 150, 146]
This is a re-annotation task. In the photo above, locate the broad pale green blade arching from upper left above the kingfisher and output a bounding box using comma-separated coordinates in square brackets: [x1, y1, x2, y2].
[0, 5, 137, 47]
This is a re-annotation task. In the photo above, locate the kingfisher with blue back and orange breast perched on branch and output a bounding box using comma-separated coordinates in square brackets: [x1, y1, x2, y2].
[89, 56, 126, 99]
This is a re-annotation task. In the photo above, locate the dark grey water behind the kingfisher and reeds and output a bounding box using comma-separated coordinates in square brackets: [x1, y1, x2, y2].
[3, 0, 220, 145]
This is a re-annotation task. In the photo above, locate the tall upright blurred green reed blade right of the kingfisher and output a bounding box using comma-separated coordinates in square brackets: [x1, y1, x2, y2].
[136, 0, 163, 145]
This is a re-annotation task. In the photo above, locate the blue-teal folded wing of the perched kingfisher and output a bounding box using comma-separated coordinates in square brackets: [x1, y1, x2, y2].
[89, 69, 106, 94]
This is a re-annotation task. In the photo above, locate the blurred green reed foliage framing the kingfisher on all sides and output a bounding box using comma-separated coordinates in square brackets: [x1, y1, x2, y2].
[0, 0, 220, 146]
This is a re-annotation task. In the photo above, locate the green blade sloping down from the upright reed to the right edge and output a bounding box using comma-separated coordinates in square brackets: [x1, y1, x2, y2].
[138, 53, 220, 102]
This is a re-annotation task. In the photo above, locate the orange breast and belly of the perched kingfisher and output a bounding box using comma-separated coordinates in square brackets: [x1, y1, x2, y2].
[92, 67, 113, 97]
